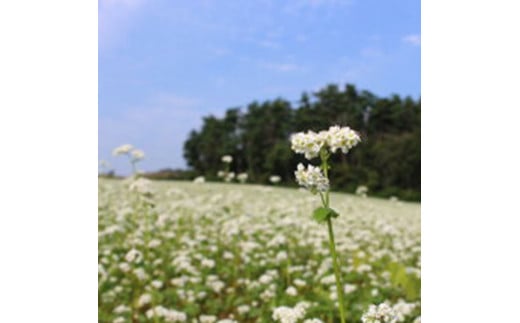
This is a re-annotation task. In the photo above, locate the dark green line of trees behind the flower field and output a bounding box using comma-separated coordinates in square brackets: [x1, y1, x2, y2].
[184, 84, 421, 201]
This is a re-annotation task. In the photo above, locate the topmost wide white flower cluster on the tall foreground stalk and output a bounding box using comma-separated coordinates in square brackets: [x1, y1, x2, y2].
[291, 126, 361, 160]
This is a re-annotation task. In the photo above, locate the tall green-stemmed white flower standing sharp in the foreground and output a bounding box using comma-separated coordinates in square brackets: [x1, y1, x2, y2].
[291, 126, 361, 323]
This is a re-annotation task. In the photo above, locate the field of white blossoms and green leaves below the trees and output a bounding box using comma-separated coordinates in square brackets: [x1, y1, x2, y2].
[98, 179, 421, 323]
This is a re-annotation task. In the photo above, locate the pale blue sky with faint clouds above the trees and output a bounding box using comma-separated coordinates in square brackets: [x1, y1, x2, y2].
[98, 0, 421, 174]
